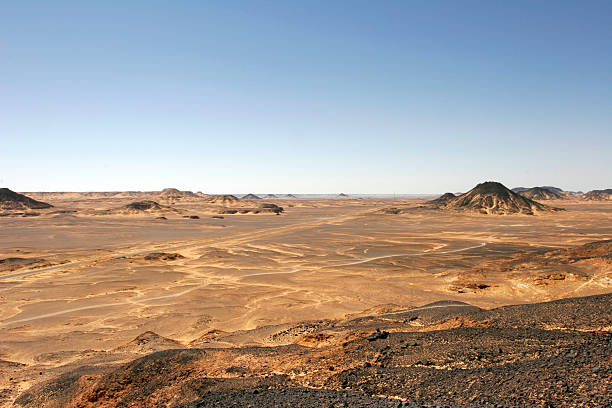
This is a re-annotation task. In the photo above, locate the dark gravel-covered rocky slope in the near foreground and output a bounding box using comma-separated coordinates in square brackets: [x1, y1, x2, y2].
[15, 294, 612, 408]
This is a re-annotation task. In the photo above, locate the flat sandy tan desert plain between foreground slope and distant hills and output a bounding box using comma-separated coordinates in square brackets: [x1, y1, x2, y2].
[0, 199, 612, 402]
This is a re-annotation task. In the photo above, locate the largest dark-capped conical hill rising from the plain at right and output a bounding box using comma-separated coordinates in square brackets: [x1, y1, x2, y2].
[433, 181, 559, 215]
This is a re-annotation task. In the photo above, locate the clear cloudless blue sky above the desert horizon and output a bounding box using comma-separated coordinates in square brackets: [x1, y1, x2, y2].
[0, 0, 612, 194]
